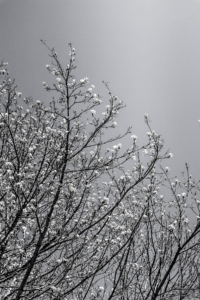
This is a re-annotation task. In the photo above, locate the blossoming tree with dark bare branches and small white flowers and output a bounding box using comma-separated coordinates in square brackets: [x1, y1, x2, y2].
[0, 42, 200, 300]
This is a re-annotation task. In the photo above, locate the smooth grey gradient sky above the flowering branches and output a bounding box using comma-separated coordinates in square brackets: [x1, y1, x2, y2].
[0, 0, 200, 179]
